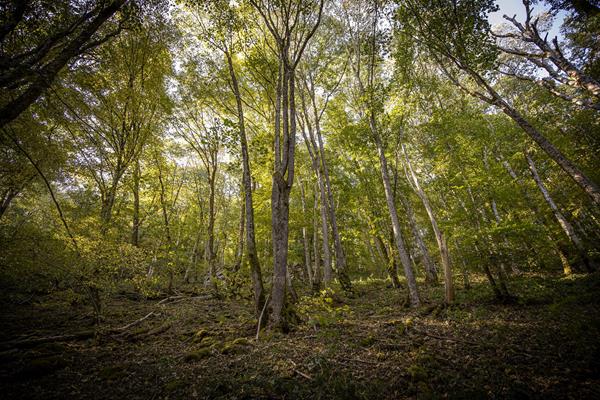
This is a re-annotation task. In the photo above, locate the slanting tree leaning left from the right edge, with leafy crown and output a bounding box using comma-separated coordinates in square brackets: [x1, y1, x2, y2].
[397, 0, 600, 204]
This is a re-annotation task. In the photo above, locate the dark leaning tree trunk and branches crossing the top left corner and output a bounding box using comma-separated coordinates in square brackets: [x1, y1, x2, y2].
[0, 0, 128, 127]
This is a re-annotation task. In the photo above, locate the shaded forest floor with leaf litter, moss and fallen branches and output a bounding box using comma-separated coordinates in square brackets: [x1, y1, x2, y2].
[0, 274, 600, 400]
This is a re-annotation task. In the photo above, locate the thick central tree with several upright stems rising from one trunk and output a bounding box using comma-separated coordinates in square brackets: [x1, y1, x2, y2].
[250, 0, 325, 330]
